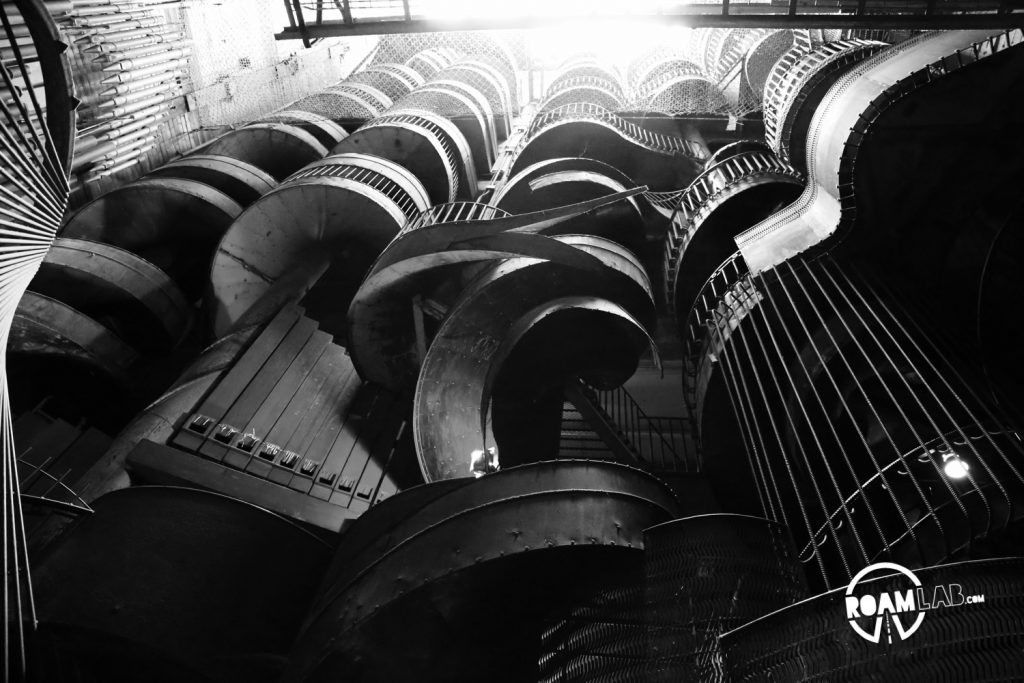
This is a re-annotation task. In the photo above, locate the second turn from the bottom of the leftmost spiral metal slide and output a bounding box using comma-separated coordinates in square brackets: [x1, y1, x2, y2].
[31, 238, 193, 350]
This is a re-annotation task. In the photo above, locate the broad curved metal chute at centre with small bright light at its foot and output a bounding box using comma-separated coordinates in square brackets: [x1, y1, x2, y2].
[413, 236, 653, 481]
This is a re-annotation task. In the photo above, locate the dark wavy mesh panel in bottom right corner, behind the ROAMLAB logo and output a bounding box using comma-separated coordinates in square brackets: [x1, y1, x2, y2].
[722, 558, 1024, 683]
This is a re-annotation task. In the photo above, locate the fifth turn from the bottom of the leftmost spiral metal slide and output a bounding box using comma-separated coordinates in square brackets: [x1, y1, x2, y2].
[203, 123, 328, 181]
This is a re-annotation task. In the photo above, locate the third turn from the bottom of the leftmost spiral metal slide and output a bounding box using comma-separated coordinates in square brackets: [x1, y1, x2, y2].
[60, 178, 242, 299]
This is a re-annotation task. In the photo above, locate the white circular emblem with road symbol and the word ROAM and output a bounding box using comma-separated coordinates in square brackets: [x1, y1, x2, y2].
[846, 562, 925, 643]
